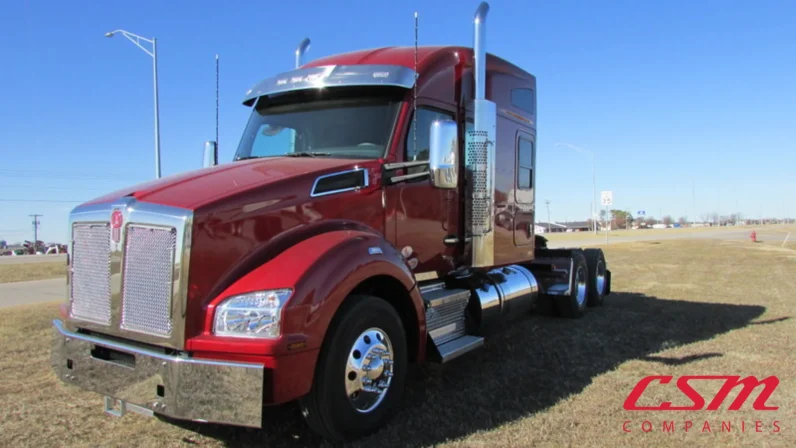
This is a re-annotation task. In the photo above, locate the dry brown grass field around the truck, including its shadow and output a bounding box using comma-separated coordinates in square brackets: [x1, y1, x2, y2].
[0, 236, 796, 448]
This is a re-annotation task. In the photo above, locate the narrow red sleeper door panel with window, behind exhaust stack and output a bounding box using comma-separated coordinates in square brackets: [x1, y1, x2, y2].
[514, 131, 536, 246]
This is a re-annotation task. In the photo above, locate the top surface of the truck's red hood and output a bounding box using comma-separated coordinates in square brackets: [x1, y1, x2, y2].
[86, 157, 372, 210]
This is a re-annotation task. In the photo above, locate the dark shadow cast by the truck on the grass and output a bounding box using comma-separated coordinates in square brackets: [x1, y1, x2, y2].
[163, 292, 765, 447]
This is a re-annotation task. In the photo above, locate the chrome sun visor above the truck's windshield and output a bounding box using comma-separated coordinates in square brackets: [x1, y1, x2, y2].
[243, 64, 416, 106]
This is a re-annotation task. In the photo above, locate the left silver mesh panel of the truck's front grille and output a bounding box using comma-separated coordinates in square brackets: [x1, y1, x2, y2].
[69, 223, 111, 325]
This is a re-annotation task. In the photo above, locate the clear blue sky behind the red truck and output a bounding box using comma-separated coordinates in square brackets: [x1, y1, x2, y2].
[0, 0, 796, 245]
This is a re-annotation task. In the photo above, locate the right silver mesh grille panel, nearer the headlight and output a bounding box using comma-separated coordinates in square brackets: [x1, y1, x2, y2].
[121, 224, 177, 337]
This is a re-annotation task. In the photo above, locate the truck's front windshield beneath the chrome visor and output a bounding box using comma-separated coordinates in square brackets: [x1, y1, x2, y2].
[235, 98, 400, 160]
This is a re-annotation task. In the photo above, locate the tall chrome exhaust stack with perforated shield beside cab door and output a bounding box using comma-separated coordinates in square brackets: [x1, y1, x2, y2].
[465, 2, 497, 268]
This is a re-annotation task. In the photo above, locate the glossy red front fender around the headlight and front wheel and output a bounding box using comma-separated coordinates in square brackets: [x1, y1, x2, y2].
[187, 230, 425, 356]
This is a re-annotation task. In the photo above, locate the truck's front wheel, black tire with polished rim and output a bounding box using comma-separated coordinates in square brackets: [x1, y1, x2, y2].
[299, 295, 408, 442]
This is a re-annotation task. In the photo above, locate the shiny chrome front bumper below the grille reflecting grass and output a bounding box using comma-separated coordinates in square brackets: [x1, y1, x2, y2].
[51, 320, 264, 428]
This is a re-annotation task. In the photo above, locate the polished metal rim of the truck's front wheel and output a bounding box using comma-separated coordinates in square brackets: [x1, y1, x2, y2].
[344, 328, 393, 413]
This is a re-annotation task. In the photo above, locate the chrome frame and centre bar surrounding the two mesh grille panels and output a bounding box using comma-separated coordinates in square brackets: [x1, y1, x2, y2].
[65, 196, 193, 350]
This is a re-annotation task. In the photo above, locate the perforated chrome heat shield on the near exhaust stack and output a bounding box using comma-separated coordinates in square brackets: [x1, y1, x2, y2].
[466, 131, 492, 235]
